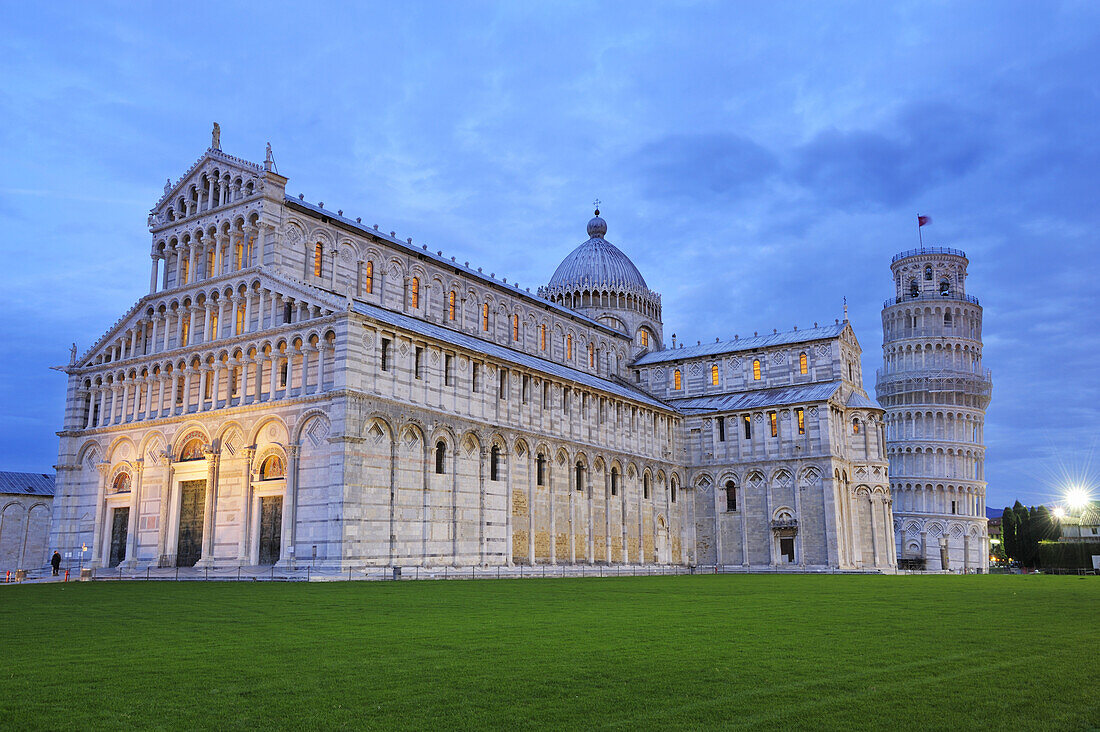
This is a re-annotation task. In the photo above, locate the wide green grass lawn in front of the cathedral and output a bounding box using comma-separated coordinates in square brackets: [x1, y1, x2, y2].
[0, 576, 1100, 730]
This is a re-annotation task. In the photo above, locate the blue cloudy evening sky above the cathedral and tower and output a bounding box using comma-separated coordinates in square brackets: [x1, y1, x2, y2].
[0, 0, 1100, 506]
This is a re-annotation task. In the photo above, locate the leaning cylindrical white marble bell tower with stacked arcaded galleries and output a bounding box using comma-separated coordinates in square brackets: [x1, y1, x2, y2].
[876, 247, 992, 571]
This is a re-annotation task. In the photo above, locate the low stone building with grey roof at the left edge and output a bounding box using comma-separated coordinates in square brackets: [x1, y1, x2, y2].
[0, 471, 54, 571]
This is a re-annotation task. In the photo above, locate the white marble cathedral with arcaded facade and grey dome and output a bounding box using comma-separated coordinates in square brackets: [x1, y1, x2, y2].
[51, 131, 898, 571]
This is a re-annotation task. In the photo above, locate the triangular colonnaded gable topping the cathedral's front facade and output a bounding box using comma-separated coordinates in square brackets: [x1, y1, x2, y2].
[149, 148, 264, 229]
